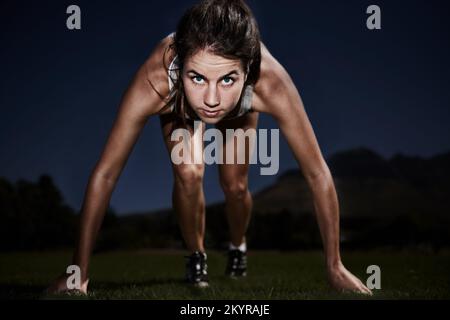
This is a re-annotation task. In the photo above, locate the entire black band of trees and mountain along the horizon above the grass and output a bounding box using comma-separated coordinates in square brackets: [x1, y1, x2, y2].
[0, 148, 450, 251]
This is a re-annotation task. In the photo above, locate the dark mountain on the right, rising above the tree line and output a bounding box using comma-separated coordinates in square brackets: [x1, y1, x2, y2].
[254, 148, 450, 217]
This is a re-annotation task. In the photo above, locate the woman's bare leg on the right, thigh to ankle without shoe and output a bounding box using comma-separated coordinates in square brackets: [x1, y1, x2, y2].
[216, 112, 258, 246]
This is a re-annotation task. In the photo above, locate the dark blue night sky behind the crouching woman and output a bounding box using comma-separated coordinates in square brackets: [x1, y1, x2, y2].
[0, 0, 450, 213]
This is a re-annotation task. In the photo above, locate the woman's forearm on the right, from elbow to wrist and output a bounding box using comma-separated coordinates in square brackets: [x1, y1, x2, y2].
[308, 170, 341, 269]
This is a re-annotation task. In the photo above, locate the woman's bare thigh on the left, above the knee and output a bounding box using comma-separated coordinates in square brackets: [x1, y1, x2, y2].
[159, 114, 205, 175]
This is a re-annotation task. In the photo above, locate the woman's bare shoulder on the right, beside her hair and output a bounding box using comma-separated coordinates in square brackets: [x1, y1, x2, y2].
[252, 42, 290, 113]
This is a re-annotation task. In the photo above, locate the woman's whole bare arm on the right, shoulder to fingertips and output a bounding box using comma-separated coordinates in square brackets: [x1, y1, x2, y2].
[253, 46, 371, 293]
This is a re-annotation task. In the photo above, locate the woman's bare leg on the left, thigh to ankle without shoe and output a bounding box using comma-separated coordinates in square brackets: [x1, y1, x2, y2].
[160, 114, 205, 252]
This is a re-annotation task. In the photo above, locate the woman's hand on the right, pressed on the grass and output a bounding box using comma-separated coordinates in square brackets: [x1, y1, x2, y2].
[328, 263, 372, 296]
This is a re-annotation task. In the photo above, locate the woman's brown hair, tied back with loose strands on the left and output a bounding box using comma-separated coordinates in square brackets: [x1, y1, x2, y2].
[163, 0, 261, 124]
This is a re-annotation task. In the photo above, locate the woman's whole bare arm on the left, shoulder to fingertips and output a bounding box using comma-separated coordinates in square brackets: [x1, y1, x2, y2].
[48, 37, 170, 292]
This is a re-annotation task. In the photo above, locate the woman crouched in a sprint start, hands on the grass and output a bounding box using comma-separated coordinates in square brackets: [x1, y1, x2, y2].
[49, 0, 371, 294]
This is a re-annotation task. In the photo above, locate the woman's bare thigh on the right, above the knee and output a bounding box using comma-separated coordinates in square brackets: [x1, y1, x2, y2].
[216, 112, 259, 183]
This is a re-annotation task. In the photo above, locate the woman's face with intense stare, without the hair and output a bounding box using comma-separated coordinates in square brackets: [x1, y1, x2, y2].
[182, 50, 247, 124]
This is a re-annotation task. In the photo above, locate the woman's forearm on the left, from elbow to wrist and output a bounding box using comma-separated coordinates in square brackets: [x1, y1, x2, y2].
[72, 173, 115, 280]
